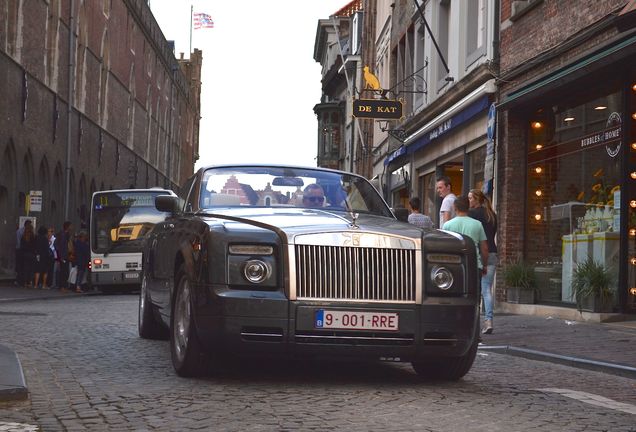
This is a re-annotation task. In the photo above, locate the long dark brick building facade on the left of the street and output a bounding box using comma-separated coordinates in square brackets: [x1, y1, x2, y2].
[0, 0, 202, 271]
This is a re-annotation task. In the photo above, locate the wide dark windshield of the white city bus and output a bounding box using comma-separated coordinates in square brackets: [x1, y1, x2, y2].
[91, 190, 170, 254]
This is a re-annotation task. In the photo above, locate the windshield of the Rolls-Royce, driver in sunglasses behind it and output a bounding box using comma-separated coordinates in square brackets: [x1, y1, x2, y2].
[199, 167, 392, 217]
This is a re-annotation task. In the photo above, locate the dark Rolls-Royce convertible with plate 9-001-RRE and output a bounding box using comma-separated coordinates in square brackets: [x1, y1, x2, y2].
[139, 165, 479, 380]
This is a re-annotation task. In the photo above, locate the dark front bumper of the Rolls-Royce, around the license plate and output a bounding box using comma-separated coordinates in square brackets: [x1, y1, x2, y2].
[195, 286, 479, 361]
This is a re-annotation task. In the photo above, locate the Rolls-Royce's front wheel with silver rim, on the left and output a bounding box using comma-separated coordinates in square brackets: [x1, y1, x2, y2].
[170, 266, 206, 377]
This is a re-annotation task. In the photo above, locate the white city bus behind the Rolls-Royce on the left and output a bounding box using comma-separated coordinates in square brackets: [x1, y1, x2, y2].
[90, 188, 175, 293]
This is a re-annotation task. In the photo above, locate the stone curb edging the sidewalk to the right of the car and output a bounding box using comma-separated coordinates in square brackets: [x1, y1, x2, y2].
[479, 345, 636, 380]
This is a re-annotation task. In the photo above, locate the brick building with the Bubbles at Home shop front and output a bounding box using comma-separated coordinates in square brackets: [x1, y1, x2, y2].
[497, 0, 636, 312]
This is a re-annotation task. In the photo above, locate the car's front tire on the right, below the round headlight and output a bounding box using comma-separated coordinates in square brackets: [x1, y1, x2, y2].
[411, 324, 479, 381]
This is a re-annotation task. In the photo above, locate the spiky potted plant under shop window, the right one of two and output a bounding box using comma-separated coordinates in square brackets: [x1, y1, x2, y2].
[572, 257, 614, 312]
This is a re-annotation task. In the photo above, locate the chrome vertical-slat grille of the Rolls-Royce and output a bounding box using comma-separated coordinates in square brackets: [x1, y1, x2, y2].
[294, 244, 420, 303]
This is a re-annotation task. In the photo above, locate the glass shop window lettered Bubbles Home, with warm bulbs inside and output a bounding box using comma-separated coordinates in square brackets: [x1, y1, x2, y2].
[526, 87, 625, 305]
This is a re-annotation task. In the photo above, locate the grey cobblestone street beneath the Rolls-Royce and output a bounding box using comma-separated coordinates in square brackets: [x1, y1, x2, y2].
[0, 295, 636, 431]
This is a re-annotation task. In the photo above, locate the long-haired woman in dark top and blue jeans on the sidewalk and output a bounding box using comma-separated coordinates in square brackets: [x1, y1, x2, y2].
[468, 189, 497, 334]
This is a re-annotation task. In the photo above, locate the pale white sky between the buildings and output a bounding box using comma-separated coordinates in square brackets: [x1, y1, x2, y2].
[150, 0, 350, 169]
